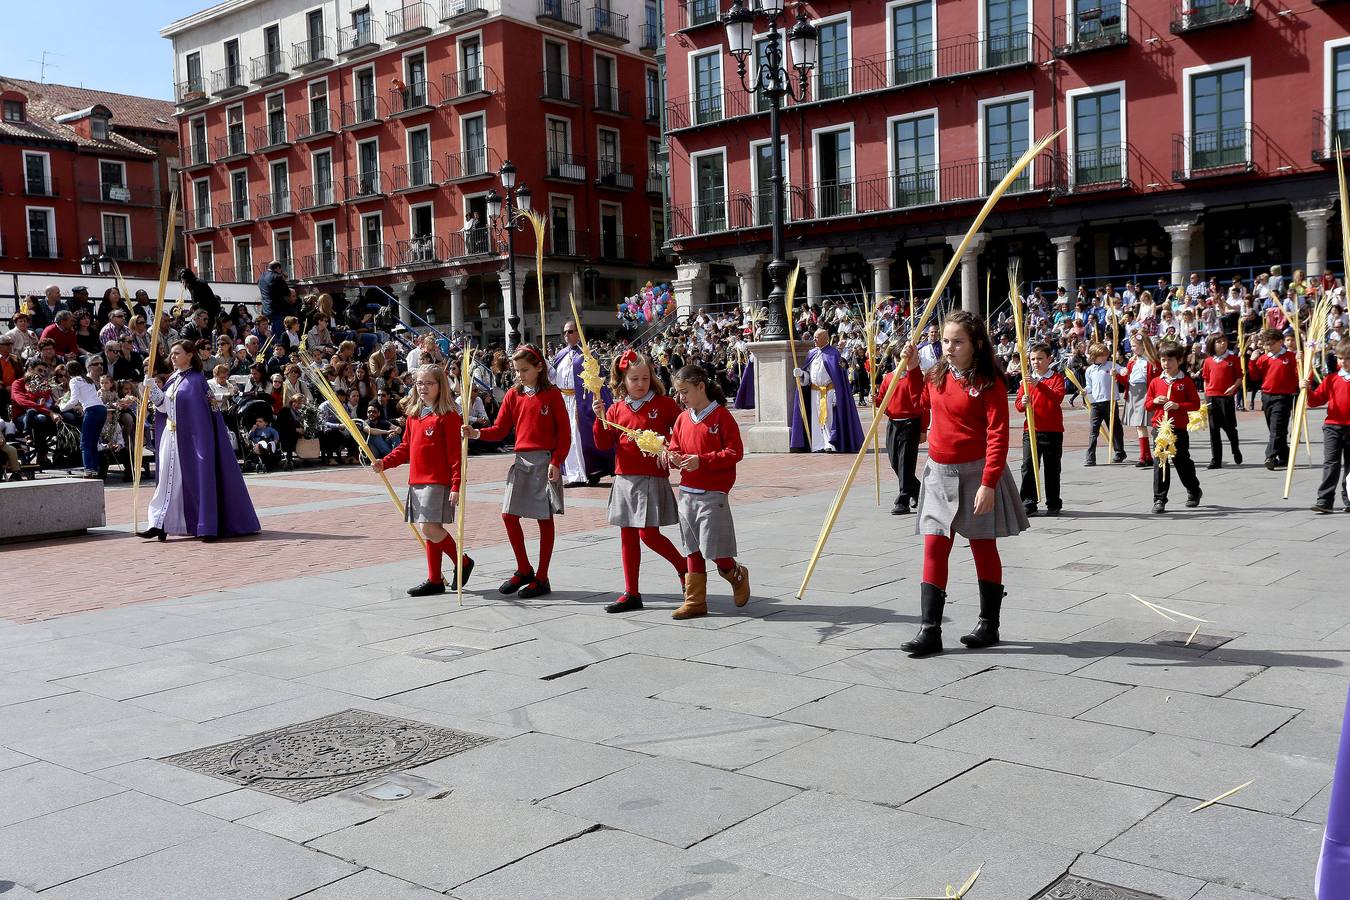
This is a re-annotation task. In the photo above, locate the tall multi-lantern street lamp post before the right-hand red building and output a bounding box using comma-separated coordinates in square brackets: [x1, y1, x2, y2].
[722, 0, 817, 341]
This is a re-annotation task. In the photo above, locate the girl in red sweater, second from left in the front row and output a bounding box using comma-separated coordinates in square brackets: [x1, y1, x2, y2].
[463, 344, 572, 600]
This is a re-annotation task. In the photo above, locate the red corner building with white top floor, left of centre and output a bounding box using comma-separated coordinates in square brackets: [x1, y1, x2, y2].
[162, 0, 672, 336]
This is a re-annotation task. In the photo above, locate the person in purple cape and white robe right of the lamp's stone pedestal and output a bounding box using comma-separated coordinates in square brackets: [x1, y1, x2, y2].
[790, 328, 863, 453]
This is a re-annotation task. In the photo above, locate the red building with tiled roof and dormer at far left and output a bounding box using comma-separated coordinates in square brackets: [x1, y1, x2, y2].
[0, 77, 178, 277]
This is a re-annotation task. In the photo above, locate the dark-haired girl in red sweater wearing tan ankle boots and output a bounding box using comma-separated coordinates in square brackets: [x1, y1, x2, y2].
[667, 366, 751, 619]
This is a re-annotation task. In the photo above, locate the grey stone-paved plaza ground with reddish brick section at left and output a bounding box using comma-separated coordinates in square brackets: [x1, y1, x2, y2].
[0, 410, 1350, 900]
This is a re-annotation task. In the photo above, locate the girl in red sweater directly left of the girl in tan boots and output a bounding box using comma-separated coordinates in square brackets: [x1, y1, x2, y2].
[593, 349, 689, 613]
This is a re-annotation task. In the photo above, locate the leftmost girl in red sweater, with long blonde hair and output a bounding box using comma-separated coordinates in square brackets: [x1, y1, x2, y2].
[371, 366, 474, 596]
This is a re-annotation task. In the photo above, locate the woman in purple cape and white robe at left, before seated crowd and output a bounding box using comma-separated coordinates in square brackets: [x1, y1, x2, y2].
[136, 340, 262, 541]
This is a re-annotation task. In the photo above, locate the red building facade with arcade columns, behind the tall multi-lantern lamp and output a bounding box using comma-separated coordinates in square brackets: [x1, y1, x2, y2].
[666, 0, 1350, 308]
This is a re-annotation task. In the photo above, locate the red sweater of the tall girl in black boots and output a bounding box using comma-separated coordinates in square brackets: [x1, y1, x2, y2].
[909, 368, 1008, 487]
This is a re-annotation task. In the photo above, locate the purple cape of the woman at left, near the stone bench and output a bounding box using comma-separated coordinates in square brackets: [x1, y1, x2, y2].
[155, 371, 262, 537]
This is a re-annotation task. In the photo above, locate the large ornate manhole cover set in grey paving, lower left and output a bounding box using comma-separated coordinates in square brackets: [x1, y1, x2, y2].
[163, 710, 493, 801]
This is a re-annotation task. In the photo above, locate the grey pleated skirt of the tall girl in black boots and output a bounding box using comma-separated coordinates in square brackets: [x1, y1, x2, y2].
[914, 459, 1031, 541]
